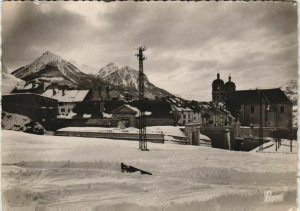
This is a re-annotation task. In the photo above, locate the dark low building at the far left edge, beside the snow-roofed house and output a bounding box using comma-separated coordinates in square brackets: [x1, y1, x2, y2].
[2, 93, 58, 129]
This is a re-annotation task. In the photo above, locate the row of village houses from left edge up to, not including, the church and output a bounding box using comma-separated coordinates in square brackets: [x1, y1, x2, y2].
[2, 88, 233, 129]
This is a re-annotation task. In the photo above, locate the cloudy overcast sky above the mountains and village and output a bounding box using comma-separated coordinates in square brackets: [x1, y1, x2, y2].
[2, 1, 298, 100]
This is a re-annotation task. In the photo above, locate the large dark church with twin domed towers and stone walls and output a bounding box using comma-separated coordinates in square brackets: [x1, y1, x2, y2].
[212, 73, 292, 128]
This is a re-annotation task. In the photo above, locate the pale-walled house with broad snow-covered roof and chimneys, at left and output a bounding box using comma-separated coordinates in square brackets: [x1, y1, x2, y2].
[42, 89, 90, 116]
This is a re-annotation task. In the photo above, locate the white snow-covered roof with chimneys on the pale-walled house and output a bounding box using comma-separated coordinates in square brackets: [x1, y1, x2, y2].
[41, 89, 89, 102]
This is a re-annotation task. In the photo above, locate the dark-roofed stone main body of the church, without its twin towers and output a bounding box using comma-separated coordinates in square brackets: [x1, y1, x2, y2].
[226, 88, 293, 128]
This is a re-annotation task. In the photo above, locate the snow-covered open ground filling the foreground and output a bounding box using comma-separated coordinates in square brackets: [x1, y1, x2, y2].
[2, 131, 297, 211]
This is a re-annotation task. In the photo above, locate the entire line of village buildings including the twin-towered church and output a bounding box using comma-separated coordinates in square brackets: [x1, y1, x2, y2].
[2, 74, 292, 131]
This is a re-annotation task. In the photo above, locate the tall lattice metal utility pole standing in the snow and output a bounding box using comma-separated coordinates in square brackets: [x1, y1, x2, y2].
[136, 47, 148, 151]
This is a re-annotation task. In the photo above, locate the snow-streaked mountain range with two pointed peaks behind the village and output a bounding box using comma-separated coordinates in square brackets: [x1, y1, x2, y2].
[12, 51, 172, 99]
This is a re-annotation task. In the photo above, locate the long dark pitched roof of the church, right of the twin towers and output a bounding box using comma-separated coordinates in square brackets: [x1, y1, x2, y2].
[227, 88, 291, 104]
